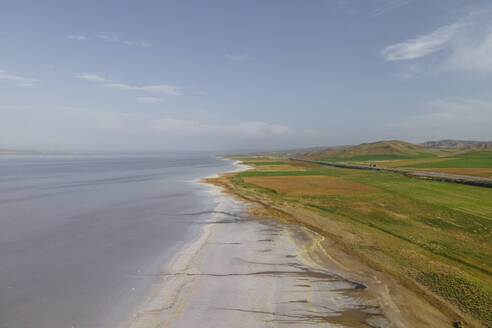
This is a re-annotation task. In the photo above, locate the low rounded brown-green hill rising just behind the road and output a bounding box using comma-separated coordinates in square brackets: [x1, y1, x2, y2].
[296, 140, 435, 159]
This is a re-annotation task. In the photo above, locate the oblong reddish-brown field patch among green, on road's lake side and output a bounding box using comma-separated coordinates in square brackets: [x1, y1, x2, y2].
[243, 175, 379, 196]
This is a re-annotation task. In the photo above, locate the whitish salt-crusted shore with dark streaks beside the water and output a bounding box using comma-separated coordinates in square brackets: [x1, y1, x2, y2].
[121, 162, 450, 328]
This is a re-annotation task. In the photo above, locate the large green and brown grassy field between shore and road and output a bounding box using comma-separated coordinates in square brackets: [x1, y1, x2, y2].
[231, 159, 492, 326]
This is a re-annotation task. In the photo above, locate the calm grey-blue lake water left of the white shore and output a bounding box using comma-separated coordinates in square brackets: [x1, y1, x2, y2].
[0, 154, 233, 328]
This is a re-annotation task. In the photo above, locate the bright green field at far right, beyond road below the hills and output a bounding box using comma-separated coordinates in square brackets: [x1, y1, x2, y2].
[404, 151, 492, 168]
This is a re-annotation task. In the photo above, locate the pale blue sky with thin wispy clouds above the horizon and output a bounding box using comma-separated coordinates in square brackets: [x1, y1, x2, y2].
[0, 0, 492, 151]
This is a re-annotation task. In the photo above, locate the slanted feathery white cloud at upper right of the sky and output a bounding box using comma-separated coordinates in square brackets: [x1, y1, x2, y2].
[381, 23, 462, 61]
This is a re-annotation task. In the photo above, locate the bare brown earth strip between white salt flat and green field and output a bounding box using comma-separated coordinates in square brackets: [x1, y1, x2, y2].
[204, 162, 485, 328]
